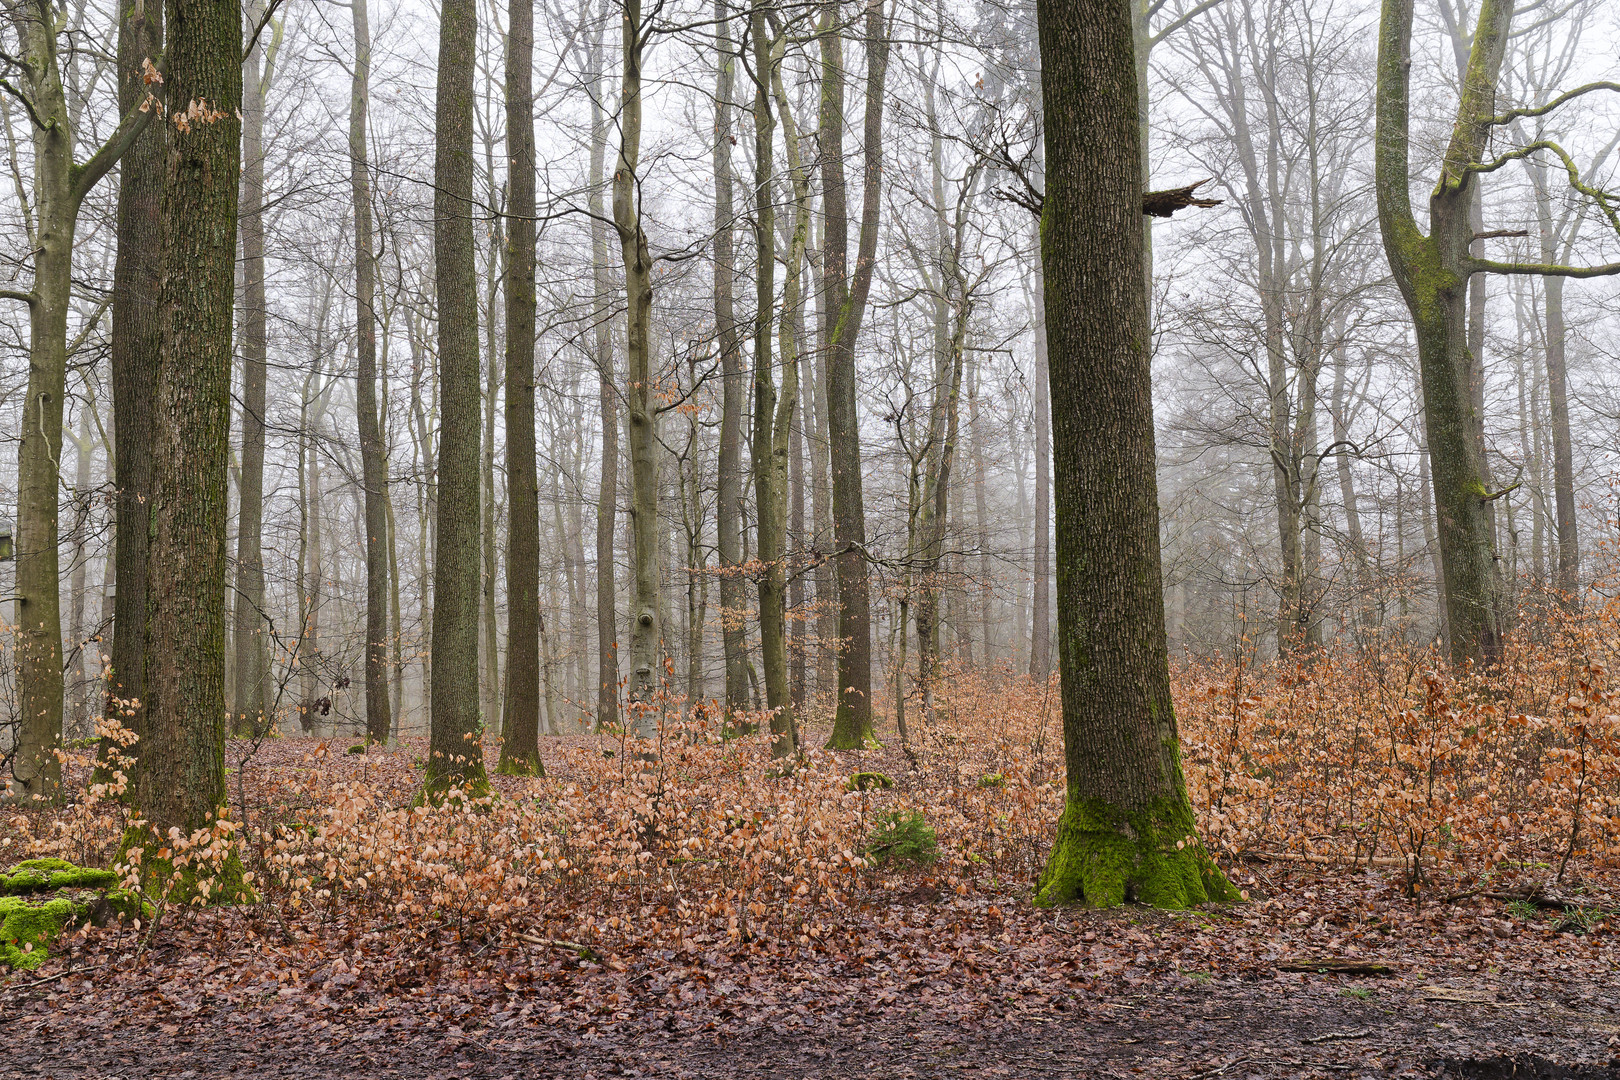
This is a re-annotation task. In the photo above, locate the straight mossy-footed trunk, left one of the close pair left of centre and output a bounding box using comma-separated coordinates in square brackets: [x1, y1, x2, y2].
[424, 0, 488, 793]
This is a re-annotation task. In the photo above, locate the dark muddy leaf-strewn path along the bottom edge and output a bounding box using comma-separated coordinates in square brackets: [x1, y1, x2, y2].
[0, 973, 1620, 1080]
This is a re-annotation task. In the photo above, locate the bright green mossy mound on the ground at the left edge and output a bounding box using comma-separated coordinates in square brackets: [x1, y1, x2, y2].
[0, 858, 151, 972]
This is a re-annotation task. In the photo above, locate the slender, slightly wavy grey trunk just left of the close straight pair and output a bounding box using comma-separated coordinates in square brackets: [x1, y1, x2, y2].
[348, 0, 394, 743]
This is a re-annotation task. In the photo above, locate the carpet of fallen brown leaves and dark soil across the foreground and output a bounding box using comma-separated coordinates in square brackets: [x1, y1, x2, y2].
[0, 740, 1620, 1080]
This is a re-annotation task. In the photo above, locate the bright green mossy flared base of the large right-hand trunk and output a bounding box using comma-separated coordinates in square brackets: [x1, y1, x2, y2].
[1035, 792, 1241, 908]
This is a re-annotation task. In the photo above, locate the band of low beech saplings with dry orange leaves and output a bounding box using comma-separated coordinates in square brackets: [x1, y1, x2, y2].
[9, 609, 1620, 950]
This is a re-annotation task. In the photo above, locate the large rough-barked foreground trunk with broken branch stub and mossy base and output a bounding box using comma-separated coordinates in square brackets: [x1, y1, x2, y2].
[1037, 0, 1236, 907]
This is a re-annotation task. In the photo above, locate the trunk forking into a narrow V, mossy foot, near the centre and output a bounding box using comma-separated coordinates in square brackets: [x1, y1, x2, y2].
[820, 0, 889, 750]
